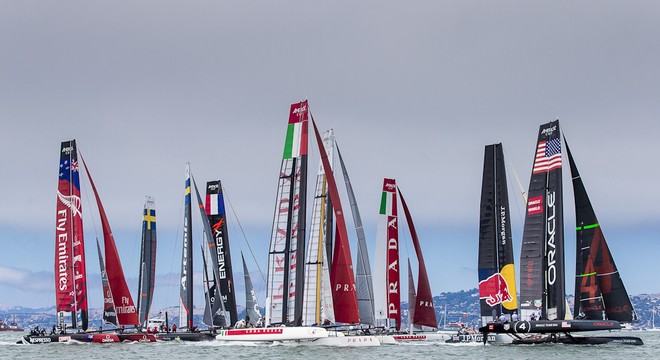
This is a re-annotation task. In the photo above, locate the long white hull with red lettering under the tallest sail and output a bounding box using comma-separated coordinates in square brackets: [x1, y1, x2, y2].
[215, 326, 328, 342]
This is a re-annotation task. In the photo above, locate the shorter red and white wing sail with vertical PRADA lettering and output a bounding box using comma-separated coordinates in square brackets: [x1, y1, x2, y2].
[374, 178, 401, 330]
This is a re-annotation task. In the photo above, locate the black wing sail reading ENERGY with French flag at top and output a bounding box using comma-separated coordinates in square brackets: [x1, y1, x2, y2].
[205, 180, 238, 324]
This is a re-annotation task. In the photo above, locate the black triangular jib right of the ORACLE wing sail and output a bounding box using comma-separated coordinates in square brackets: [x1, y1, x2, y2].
[566, 144, 637, 322]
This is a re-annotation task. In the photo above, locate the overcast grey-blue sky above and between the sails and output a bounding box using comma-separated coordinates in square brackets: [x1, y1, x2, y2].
[0, 0, 660, 308]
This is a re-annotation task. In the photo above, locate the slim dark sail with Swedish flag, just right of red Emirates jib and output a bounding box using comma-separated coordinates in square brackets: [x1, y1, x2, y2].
[138, 196, 156, 328]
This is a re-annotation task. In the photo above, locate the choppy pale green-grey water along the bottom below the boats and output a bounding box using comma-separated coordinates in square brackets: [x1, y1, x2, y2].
[0, 331, 660, 360]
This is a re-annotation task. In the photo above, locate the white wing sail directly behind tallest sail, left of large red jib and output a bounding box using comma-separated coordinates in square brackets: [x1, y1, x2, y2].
[303, 130, 335, 325]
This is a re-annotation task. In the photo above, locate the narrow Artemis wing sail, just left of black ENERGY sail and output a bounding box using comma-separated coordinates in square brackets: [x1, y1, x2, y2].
[179, 163, 193, 331]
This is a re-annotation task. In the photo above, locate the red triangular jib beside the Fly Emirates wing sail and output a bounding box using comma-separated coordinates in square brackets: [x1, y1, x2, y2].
[81, 157, 139, 326]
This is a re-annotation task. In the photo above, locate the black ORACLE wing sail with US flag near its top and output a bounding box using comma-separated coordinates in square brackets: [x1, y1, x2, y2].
[520, 120, 566, 320]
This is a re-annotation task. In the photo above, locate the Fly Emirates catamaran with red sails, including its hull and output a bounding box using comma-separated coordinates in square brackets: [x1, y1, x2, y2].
[21, 140, 155, 344]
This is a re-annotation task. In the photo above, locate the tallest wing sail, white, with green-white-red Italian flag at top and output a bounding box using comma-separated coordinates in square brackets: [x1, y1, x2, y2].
[266, 101, 308, 325]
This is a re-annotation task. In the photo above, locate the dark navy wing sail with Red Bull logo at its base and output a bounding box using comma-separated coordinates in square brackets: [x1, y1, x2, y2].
[478, 144, 518, 324]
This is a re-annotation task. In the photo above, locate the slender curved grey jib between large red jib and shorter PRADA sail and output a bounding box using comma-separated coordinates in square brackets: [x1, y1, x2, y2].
[337, 145, 376, 325]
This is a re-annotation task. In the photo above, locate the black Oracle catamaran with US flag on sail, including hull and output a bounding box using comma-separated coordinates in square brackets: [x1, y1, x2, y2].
[479, 120, 643, 345]
